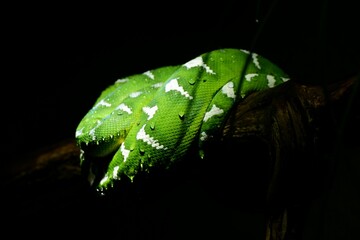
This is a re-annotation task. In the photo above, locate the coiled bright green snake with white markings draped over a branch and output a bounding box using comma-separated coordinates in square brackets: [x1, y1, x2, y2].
[75, 48, 289, 191]
